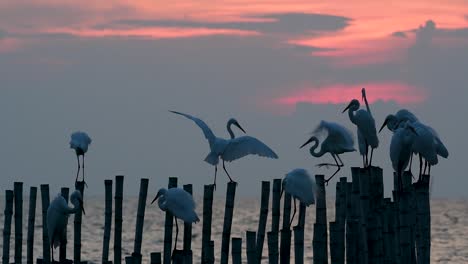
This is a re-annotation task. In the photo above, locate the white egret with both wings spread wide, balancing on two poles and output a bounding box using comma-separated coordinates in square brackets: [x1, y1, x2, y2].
[170, 111, 278, 188]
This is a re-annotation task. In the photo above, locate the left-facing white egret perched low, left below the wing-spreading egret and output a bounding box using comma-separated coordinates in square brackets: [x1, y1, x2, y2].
[151, 188, 200, 255]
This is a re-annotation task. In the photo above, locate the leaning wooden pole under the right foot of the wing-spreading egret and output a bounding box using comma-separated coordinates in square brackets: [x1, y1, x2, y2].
[221, 182, 237, 264]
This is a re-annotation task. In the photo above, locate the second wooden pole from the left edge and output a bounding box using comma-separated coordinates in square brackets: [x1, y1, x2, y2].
[13, 182, 23, 264]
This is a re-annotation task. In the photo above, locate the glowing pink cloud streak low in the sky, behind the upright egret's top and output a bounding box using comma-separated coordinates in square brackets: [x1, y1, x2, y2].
[273, 82, 427, 106]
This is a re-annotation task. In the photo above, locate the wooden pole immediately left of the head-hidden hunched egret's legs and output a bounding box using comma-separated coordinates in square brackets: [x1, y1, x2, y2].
[280, 192, 291, 264]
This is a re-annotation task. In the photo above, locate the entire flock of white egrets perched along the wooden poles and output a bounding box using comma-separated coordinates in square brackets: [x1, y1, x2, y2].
[47, 88, 449, 258]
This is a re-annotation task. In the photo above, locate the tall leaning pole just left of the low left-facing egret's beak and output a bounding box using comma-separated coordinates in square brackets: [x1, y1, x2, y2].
[132, 179, 149, 263]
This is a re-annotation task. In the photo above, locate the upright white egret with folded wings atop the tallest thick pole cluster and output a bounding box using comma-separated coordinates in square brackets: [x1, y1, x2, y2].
[343, 88, 379, 167]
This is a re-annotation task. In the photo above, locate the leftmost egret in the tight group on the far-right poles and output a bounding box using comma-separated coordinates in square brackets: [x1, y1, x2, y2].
[390, 123, 417, 191]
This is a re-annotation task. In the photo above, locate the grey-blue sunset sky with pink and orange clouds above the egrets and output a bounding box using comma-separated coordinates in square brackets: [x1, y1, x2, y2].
[0, 0, 468, 198]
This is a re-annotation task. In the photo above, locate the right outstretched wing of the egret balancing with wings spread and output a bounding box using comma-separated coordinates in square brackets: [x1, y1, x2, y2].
[221, 136, 278, 161]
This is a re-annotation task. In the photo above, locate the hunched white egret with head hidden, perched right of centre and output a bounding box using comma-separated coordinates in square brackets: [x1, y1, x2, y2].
[281, 169, 317, 226]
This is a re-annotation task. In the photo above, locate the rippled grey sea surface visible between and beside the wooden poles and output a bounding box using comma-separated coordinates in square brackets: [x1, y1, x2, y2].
[0, 196, 468, 263]
